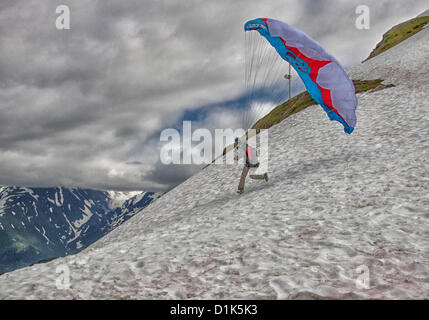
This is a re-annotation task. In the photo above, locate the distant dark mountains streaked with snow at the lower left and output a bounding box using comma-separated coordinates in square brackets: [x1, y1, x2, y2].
[0, 187, 158, 273]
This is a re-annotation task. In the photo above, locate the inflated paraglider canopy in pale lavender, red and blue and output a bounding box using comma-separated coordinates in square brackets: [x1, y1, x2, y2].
[244, 18, 357, 134]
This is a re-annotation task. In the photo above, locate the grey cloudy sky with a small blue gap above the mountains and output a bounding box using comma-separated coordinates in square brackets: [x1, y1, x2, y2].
[0, 0, 428, 191]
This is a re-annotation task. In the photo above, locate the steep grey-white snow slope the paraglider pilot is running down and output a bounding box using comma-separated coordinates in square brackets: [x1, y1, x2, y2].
[0, 28, 429, 299]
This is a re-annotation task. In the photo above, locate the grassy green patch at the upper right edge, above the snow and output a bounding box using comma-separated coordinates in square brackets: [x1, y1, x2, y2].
[364, 16, 429, 62]
